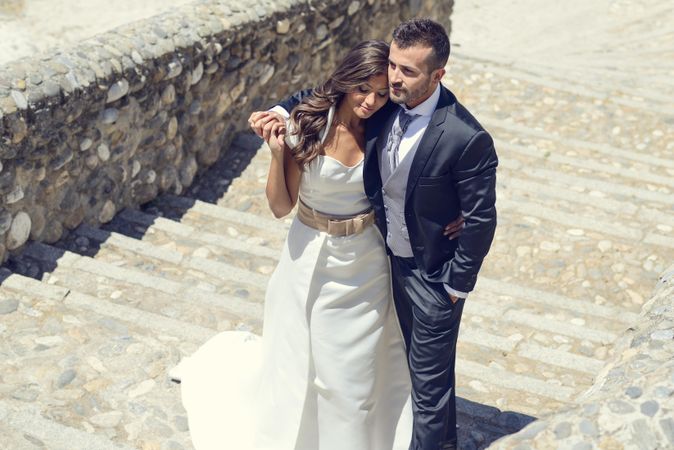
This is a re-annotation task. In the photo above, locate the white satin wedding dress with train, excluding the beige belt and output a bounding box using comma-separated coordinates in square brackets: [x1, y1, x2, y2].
[177, 112, 412, 450]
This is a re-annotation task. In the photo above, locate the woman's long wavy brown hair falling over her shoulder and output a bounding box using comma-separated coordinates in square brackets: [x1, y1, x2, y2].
[290, 40, 389, 169]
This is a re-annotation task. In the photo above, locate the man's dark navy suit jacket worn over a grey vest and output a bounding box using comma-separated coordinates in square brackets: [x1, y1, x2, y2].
[279, 86, 498, 292]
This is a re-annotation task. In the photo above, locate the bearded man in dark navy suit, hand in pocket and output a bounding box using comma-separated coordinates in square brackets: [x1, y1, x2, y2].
[251, 19, 498, 450]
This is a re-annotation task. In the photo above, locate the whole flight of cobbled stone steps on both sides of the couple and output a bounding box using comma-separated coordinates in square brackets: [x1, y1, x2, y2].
[0, 0, 674, 450]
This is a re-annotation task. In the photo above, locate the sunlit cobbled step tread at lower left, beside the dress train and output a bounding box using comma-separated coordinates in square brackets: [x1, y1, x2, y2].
[0, 274, 194, 449]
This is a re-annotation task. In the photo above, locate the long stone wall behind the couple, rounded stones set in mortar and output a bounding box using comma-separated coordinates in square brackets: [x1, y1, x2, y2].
[0, 0, 452, 262]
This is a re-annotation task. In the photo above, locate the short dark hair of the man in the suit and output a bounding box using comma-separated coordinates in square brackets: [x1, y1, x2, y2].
[393, 19, 449, 70]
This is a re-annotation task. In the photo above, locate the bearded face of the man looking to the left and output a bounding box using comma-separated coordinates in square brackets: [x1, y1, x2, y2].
[388, 42, 445, 108]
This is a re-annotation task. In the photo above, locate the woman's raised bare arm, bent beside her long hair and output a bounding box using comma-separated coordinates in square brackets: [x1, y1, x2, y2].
[266, 124, 302, 218]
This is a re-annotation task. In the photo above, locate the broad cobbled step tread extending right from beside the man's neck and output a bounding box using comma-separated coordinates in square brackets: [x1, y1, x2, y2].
[445, 60, 671, 160]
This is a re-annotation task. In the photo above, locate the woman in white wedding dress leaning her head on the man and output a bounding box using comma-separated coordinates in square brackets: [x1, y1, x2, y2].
[174, 41, 456, 450]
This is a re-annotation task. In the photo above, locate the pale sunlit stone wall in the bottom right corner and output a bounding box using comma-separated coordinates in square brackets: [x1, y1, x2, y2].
[489, 265, 674, 450]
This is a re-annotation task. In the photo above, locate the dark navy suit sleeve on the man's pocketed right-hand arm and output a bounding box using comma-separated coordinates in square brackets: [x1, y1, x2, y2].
[445, 131, 498, 292]
